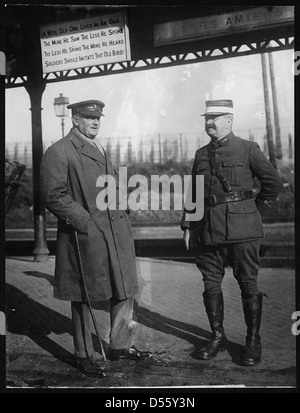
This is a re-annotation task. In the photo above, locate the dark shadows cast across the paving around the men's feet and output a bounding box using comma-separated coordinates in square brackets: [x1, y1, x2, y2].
[6, 271, 242, 374]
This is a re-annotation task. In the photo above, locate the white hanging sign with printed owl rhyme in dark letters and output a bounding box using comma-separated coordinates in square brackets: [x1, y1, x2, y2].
[40, 10, 131, 73]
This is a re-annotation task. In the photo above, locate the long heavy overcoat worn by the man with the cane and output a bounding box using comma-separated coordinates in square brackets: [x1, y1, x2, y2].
[40, 128, 138, 301]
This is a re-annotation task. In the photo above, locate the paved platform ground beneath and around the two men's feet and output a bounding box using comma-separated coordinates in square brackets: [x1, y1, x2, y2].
[6, 257, 296, 391]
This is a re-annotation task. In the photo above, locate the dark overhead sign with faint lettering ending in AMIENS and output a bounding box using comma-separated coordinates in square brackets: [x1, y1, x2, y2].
[154, 6, 294, 46]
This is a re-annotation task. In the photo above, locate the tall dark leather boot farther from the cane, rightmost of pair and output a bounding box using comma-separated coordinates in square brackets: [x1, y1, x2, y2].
[241, 293, 263, 366]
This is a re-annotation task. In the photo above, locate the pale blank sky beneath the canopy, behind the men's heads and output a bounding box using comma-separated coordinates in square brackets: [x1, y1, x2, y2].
[6, 50, 294, 144]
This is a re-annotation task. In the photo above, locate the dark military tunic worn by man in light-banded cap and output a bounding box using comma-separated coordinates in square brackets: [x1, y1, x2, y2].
[181, 132, 283, 245]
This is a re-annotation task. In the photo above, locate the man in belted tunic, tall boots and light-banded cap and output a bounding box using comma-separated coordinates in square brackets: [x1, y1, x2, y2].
[181, 100, 283, 366]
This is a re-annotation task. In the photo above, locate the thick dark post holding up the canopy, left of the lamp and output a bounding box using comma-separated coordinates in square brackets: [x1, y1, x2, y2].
[25, 75, 49, 262]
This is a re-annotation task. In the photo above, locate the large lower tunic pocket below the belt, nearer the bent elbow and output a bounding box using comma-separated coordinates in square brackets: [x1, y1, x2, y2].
[226, 199, 264, 241]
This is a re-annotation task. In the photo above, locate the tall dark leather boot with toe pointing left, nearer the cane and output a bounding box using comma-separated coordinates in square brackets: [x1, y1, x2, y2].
[195, 292, 226, 360]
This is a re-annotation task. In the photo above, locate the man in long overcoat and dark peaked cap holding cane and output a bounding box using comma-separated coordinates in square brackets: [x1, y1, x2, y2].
[41, 100, 151, 377]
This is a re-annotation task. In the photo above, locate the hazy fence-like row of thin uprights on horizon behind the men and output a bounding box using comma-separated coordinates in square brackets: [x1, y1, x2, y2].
[5, 128, 294, 168]
